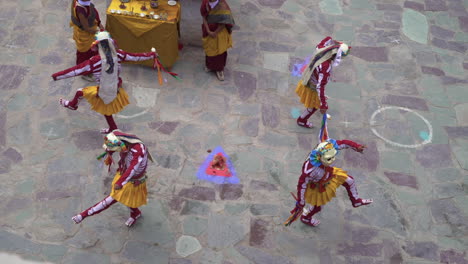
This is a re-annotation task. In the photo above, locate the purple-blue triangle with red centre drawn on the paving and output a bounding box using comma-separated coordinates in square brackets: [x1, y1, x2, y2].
[197, 146, 240, 184]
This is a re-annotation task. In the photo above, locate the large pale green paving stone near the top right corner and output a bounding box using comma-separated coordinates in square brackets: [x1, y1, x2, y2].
[402, 8, 429, 44]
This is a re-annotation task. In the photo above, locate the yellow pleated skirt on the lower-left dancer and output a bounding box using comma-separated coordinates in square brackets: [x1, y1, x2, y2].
[110, 172, 148, 208]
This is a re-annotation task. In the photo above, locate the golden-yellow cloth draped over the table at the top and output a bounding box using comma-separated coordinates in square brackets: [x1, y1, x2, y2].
[106, 0, 181, 68]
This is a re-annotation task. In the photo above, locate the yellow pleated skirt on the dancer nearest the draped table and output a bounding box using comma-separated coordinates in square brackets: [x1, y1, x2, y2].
[83, 86, 130, 115]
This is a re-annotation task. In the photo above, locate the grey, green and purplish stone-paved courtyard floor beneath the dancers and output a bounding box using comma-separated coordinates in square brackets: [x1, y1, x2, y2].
[0, 0, 468, 264]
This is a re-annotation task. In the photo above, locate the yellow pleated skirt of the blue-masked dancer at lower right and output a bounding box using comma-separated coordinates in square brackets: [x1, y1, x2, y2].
[305, 167, 348, 206]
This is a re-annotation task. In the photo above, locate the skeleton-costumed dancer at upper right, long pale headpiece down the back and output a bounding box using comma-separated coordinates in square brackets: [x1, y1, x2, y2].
[296, 37, 351, 128]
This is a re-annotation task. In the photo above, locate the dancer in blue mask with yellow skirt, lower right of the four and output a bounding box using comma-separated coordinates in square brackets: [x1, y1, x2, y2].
[285, 139, 372, 226]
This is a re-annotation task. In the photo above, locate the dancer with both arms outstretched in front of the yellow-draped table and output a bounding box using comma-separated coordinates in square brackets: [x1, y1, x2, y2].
[52, 31, 158, 134]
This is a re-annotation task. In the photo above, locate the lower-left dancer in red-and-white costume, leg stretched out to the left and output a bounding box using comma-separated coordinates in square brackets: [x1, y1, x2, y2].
[72, 130, 153, 227]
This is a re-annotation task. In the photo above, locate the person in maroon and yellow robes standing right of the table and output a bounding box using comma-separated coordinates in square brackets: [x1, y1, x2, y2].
[200, 0, 234, 81]
